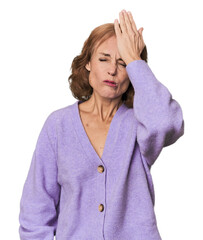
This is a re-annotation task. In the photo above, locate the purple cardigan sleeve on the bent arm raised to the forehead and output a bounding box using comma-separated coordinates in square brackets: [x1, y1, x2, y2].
[126, 60, 184, 167]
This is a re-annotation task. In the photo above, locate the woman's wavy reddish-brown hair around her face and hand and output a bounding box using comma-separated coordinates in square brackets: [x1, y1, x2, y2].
[68, 23, 147, 108]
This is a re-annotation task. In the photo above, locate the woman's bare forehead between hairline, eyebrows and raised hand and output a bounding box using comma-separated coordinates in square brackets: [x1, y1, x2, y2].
[95, 36, 120, 58]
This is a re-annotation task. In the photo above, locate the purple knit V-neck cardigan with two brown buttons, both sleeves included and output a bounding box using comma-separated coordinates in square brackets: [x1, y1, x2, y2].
[19, 60, 184, 240]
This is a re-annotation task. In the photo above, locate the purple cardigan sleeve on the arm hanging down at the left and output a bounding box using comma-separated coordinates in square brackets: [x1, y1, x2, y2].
[19, 113, 60, 240]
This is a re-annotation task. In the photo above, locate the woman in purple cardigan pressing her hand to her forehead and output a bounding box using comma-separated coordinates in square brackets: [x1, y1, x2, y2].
[19, 11, 184, 240]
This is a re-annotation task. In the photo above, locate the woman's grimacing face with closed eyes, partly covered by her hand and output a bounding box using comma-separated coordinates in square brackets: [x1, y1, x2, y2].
[85, 36, 130, 99]
